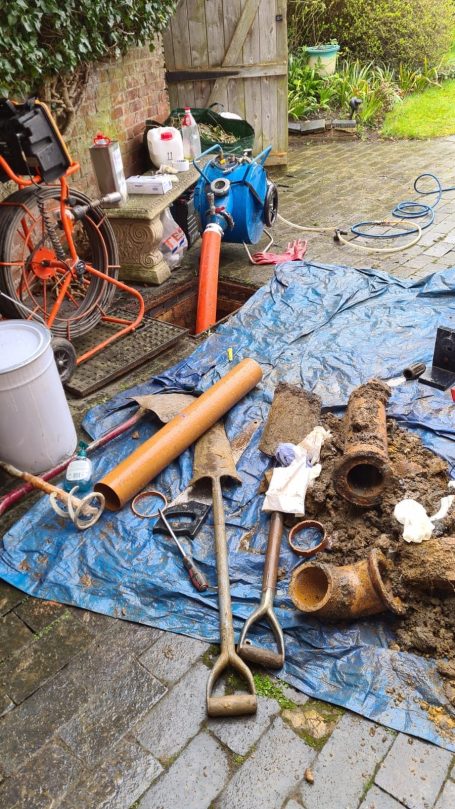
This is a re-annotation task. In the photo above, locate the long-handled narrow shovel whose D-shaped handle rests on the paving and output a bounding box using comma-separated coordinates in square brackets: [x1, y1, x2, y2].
[192, 422, 257, 716]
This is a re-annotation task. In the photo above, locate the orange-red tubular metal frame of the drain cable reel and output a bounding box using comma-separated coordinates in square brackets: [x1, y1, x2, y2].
[0, 155, 145, 365]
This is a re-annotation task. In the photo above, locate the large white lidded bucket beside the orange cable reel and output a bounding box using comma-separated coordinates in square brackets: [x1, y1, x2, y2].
[0, 320, 77, 473]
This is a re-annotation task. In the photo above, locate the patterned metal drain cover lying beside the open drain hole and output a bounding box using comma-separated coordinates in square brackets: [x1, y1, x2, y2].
[65, 310, 188, 398]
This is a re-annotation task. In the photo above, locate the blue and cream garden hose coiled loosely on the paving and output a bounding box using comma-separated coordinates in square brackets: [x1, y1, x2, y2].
[278, 172, 455, 253]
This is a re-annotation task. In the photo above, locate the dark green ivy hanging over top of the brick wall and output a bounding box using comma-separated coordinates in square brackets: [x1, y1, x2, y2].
[0, 0, 175, 129]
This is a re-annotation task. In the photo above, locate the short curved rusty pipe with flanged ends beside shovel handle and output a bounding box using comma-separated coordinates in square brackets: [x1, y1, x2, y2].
[289, 548, 404, 621]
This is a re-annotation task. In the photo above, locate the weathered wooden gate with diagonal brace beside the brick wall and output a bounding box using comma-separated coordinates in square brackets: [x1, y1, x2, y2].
[164, 0, 288, 165]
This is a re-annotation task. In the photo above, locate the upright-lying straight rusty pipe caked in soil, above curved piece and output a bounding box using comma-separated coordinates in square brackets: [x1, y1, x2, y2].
[333, 379, 391, 506]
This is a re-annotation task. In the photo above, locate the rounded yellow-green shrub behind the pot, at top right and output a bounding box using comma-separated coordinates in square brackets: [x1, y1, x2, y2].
[288, 0, 454, 68]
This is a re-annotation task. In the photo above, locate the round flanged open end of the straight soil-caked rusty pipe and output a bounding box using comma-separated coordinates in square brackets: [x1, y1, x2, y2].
[333, 450, 390, 506]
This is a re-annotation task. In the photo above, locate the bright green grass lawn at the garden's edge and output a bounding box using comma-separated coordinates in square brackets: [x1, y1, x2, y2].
[382, 79, 455, 138]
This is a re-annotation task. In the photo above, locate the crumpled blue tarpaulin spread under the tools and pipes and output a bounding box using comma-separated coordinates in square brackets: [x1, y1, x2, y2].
[0, 262, 455, 750]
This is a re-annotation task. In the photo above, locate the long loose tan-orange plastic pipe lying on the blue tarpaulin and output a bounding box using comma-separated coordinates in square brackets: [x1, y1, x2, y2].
[95, 359, 262, 511]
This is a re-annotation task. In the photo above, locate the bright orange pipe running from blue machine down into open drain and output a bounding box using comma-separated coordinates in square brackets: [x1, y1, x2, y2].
[195, 229, 221, 334]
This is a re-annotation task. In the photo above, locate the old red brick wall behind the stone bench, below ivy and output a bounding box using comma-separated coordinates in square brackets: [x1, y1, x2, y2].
[65, 39, 169, 196]
